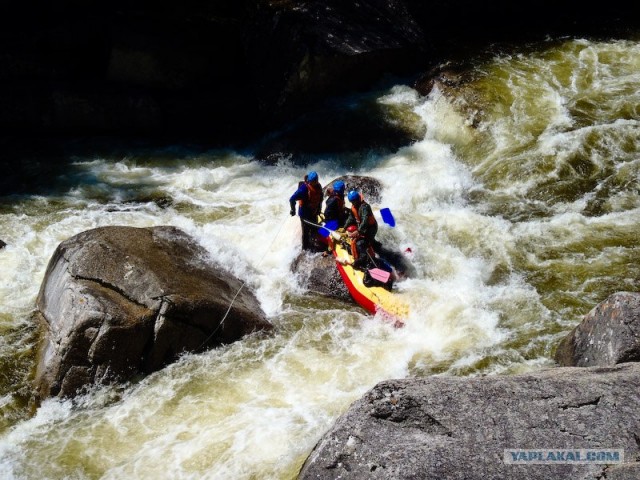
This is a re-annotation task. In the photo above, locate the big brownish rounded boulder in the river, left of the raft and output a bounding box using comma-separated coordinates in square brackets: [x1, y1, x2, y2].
[35, 227, 271, 398]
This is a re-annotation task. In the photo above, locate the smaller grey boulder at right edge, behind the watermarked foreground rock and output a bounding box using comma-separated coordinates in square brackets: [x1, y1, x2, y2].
[555, 292, 640, 367]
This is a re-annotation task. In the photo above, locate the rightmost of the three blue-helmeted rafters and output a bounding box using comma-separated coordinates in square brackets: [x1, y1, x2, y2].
[344, 190, 382, 268]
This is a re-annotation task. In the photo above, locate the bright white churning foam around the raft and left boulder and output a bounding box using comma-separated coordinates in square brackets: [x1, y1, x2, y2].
[0, 119, 552, 479]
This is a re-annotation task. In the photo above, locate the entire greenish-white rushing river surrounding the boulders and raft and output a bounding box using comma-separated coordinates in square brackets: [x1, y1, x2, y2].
[0, 41, 640, 480]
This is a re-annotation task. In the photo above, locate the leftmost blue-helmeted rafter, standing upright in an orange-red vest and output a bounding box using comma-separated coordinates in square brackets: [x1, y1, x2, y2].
[289, 171, 323, 250]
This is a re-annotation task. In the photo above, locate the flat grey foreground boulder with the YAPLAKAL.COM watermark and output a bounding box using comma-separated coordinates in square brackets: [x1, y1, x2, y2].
[298, 363, 640, 480]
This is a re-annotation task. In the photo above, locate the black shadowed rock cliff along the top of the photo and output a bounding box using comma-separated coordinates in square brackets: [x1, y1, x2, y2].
[0, 0, 636, 142]
